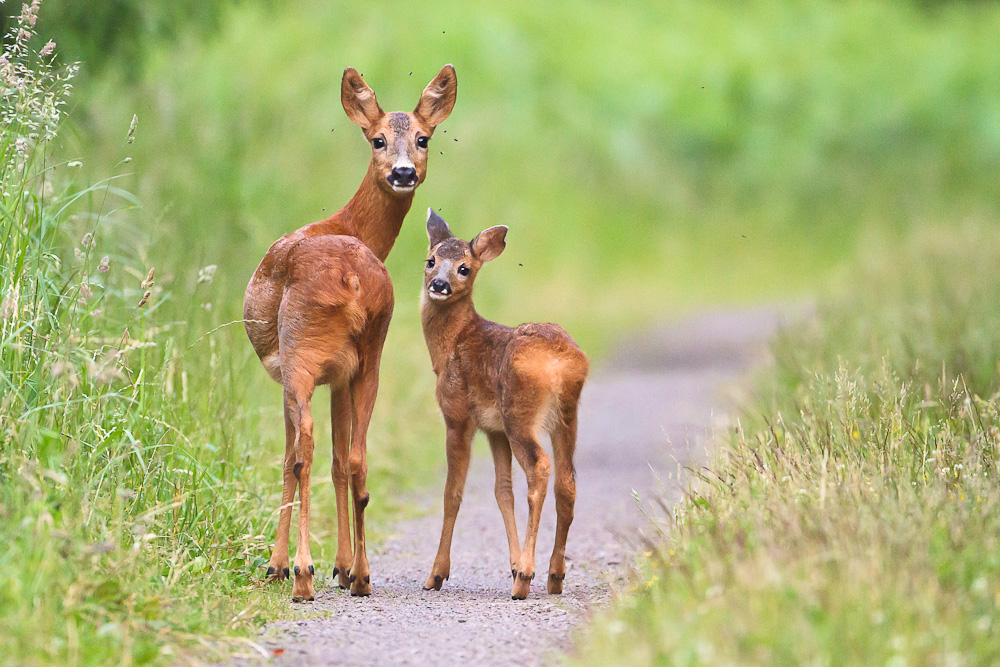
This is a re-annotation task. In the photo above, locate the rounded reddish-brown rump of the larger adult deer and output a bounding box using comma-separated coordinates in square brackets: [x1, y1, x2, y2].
[247, 235, 393, 385]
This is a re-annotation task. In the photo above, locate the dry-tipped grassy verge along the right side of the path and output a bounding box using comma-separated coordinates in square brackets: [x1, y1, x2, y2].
[581, 225, 1000, 665]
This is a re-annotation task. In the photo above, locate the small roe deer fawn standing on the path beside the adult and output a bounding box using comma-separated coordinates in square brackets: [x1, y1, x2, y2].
[420, 210, 589, 600]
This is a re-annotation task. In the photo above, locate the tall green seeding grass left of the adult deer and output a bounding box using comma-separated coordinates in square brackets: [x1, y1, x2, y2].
[0, 2, 288, 664]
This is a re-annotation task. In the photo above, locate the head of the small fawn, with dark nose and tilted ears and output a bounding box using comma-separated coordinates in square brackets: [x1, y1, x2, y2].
[424, 209, 507, 301]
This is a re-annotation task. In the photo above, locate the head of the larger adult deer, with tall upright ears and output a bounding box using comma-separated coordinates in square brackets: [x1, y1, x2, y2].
[340, 65, 458, 194]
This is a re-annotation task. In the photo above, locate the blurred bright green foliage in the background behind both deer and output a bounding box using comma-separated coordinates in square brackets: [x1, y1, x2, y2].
[64, 0, 1000, 350]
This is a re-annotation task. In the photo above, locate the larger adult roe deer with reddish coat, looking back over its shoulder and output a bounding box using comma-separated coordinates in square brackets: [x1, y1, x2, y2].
[243, 65, 458, 601]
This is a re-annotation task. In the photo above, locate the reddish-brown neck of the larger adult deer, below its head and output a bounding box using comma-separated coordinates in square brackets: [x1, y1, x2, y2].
[344, 165, 413, 262]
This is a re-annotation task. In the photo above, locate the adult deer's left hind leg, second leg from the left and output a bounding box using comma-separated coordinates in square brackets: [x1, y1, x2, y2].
[285, 379, 316, 602]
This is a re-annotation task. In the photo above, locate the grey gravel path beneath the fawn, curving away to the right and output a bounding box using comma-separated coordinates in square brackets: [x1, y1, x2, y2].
[244, 310, 781, 666]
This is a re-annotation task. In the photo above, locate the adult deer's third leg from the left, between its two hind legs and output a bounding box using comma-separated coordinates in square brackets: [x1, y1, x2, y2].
[330, 387, 354, 588]
